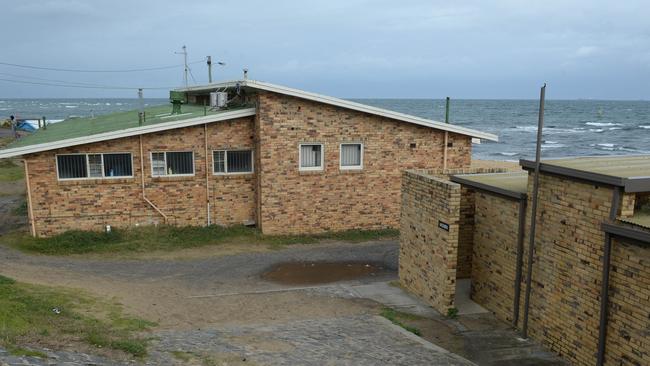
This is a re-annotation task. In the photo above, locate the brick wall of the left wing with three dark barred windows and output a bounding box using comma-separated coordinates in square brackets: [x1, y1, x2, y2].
[26, 118, 256, 235]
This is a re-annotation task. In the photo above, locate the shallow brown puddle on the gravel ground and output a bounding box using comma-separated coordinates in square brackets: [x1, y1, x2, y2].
[262, 262, 385, 285]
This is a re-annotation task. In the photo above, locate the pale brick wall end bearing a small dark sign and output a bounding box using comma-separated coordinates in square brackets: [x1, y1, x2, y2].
[399, 171, 461, 314]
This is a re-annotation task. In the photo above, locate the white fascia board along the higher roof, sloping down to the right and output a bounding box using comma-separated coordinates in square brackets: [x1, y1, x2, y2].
[172, 80, 499, 141]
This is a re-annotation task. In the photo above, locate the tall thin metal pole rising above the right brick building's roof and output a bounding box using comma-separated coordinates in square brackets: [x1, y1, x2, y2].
[521, 83, 546, 338]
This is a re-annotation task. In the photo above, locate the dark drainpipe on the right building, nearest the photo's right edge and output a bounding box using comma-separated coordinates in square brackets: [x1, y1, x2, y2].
[596, 187, 621, 366]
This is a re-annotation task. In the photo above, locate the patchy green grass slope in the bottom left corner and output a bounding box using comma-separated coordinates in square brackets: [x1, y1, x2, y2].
[0, 276, 155, 357]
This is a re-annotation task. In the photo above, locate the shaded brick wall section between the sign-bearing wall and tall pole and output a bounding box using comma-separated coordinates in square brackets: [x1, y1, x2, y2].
[471, 191, 519, 323]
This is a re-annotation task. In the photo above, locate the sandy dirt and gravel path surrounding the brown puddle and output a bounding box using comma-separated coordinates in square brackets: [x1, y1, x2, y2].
[0, 241, 397, 329]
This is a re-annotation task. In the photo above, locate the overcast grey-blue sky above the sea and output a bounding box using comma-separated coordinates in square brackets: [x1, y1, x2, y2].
[0, 0, 650, 100]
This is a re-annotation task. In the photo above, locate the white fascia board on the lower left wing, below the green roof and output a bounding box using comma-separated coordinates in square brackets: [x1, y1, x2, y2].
[0, 108, 257, 159]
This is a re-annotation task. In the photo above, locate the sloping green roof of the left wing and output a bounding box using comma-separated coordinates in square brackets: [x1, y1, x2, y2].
[6, 104, 233, 149]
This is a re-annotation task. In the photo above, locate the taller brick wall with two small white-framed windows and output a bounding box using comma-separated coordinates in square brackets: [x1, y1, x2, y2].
[257, 93, 471, 234]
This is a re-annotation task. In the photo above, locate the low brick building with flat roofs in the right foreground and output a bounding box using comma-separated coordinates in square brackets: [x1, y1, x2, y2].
[400, 156, 650, 365]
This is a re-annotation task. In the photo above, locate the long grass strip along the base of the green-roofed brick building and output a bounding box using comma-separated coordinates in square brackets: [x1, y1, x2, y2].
[2, 225, 399, 255]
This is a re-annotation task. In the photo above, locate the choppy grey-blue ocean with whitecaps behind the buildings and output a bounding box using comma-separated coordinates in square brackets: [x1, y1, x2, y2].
[0, 99, 650, 161]
